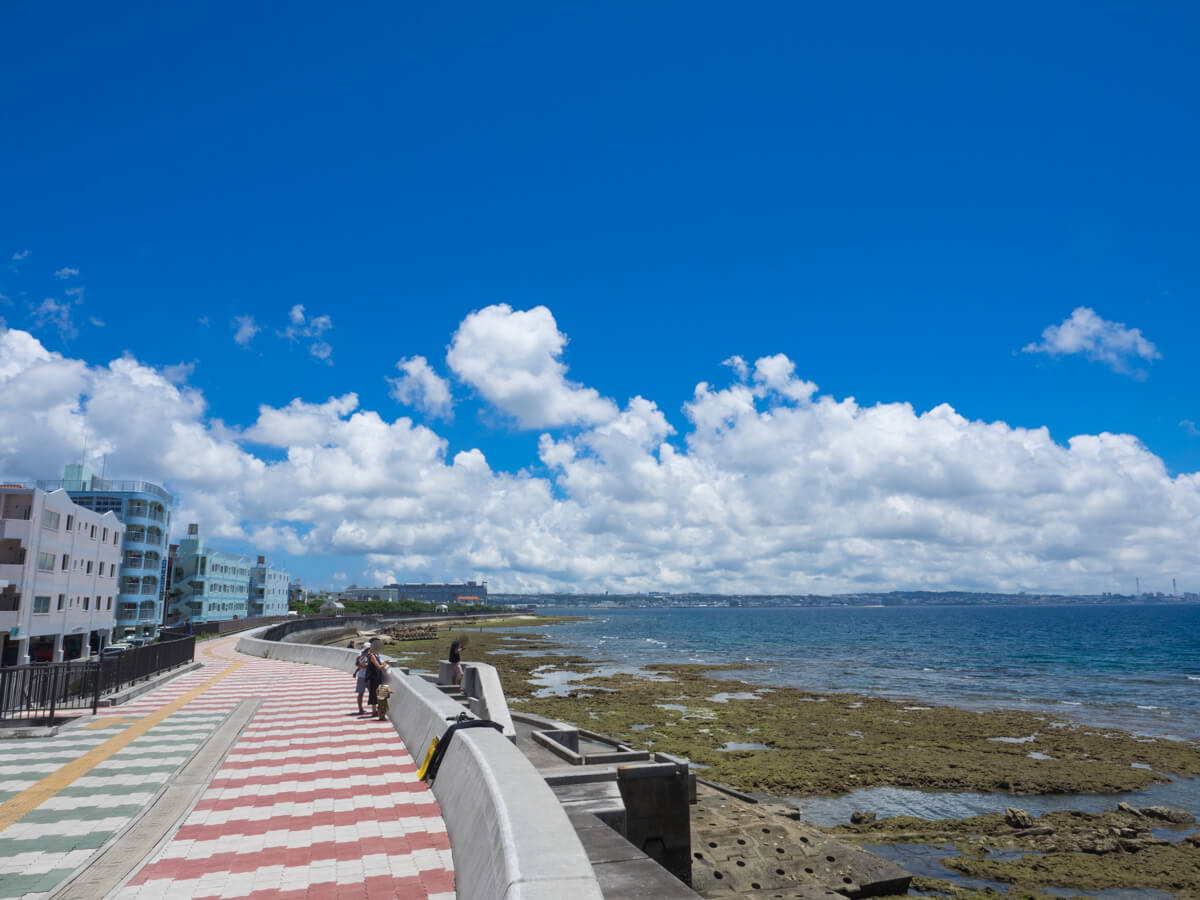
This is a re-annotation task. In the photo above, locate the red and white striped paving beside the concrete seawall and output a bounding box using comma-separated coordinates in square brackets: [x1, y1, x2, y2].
[112, 638, 455, 900]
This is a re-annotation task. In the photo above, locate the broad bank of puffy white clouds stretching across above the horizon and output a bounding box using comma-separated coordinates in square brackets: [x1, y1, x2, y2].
[0, 304, 1200, 593]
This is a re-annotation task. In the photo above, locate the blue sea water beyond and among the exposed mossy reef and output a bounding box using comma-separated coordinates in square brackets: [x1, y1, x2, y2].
[544, 605, 1200, 822]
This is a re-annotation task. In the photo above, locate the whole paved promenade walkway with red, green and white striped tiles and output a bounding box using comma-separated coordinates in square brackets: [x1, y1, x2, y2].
[0, 636, 455, 900]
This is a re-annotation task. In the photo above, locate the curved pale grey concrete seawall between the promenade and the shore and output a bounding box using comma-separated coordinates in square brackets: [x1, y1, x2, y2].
[238, 628, 602, 900]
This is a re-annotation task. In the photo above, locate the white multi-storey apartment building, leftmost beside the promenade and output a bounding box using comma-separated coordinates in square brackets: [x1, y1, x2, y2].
[0, 482, 125, 666]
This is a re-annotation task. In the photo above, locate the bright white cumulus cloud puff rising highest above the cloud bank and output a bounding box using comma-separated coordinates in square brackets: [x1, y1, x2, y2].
[446, 304, 617, 428]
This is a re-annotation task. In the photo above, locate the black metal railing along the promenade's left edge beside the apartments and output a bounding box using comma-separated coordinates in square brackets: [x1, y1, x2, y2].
[0, 636, 196, 722]
